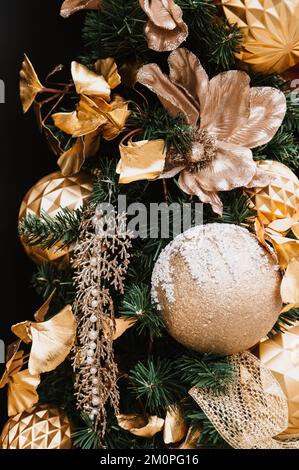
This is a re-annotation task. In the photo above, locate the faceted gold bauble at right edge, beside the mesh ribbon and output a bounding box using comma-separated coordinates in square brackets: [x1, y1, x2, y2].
[259, 323, 299, 437]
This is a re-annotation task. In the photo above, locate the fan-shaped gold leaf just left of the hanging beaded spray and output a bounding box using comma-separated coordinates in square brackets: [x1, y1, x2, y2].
[28, 305, 76, 375]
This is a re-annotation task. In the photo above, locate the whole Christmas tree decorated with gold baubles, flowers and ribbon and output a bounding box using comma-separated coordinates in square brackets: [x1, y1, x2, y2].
[0, 0, 299, 449]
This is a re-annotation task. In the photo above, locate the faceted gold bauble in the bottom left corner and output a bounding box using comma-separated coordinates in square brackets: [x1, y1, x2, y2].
[0, 405, 72, 449]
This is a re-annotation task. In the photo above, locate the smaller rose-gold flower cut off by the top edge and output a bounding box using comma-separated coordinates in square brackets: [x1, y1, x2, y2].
[139, 0, 188, 52]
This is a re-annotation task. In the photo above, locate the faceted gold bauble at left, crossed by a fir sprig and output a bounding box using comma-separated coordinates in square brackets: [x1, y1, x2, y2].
[19, 171, 92, 268]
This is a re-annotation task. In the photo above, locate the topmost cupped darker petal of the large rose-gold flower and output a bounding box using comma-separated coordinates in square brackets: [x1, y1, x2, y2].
[168, 47, 209, 111]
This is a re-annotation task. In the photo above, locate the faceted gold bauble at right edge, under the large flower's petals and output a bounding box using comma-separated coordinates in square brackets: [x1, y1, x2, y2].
[245, 160, 299, 226]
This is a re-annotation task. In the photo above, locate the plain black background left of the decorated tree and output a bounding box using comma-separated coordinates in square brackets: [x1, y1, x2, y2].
[0, 0, 83, 422]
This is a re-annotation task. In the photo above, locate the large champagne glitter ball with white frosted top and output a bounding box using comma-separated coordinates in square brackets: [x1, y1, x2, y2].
[152, 223, 282, 355]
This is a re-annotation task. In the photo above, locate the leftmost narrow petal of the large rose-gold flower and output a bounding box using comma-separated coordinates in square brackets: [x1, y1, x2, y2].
[137, 64, 199, 126]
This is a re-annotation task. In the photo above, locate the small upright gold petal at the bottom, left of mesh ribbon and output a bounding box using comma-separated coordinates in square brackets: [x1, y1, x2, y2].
[163, 405, 188, 444]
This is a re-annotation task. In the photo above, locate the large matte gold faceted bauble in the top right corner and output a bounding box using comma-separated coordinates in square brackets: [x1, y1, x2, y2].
[221, 0, 299, 73]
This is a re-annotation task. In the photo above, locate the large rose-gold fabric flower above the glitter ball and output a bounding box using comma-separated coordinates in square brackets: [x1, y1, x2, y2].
[119, 48, 286, 215]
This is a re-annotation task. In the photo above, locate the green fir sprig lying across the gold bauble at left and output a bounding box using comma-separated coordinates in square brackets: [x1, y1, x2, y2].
[19, 208, 82, 249]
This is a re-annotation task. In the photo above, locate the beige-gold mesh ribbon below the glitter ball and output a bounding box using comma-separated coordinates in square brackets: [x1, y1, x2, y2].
[189, 352, 299, 449]
